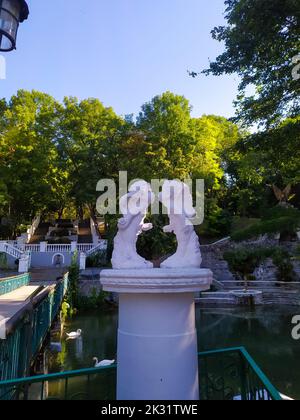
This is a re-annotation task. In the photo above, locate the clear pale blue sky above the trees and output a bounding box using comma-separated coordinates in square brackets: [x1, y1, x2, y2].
[0, 0, 238, 117]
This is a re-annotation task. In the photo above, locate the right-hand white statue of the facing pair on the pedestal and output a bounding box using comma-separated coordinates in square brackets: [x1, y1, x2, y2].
[160, 181, 202, 268]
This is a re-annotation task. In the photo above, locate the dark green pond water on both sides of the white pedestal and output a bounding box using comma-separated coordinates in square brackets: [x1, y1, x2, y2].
[49, 307, 300, 400]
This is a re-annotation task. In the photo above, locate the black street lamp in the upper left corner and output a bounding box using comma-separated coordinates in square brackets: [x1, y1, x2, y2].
[0, 0, 29, 52]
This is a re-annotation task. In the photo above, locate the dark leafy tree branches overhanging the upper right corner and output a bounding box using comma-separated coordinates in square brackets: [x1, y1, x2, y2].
[205, 0, 300, 127]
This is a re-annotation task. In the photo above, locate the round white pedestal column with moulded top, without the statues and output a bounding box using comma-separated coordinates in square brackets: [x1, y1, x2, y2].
[101, 269, 213, 401]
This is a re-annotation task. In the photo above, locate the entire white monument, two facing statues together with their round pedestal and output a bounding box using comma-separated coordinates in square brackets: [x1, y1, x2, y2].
[101, 181, 213, 400]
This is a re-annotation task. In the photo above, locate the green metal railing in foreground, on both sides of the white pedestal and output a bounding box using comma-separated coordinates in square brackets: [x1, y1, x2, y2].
[0, 347, 281, 401]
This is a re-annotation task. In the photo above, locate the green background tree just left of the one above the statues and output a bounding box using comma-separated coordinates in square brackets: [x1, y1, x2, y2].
[57, 97, 124, 217]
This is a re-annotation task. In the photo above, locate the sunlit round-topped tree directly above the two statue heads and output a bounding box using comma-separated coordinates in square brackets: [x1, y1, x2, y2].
[137, 92, 239, 189]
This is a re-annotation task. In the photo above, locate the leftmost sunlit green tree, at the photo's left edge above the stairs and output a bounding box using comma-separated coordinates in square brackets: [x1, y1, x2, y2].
[0, 90, 60, 231]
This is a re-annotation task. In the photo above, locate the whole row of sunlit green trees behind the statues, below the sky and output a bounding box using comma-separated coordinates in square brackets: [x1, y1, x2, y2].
[0, 90, 240, 235]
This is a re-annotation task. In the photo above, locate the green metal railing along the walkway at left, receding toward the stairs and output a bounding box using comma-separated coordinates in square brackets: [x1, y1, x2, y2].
[0, 275, 68, 400]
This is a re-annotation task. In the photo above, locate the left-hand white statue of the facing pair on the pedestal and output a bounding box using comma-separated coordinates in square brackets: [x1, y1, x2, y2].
[112, 181, 155, 269]
